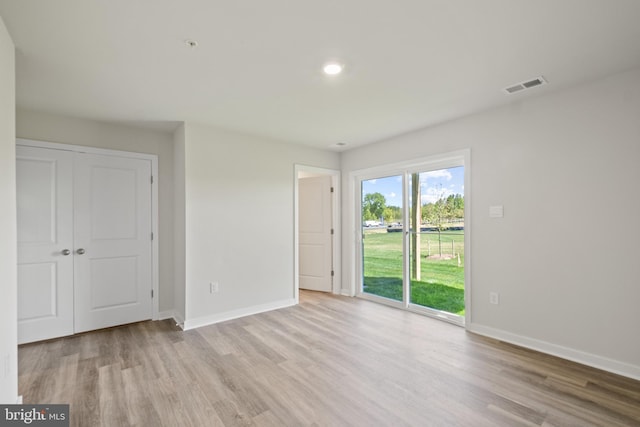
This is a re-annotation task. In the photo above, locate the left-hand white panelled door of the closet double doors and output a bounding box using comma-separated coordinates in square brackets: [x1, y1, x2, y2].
[16, 146, 74, 344]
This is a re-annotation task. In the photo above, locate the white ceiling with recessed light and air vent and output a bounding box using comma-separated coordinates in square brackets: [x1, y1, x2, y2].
[0, 0, 640, 149]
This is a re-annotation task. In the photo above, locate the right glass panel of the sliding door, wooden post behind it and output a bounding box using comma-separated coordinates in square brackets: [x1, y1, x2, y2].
[408, 166, 465, 316]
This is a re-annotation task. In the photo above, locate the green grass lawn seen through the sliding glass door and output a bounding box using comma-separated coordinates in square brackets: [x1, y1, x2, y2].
[364, 230, 465, 316]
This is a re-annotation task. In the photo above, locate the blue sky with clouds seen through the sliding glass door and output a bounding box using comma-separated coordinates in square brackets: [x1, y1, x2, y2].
[362, 166, 464, 207]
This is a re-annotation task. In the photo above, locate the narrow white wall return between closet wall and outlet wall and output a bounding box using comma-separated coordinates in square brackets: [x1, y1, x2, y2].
[173, 123, 186, 323]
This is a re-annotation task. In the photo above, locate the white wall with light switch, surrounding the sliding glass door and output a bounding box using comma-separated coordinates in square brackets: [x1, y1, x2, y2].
[342, 70, 640, 378]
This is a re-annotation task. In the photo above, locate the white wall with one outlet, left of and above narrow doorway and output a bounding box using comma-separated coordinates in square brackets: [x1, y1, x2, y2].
[180, 123, 339, 327]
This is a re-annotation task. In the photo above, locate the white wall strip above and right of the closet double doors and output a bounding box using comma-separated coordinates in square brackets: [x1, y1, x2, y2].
[16, 109, 174, 312]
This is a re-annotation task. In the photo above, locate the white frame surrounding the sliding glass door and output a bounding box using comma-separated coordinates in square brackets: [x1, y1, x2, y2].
[348, 149, 471, 326]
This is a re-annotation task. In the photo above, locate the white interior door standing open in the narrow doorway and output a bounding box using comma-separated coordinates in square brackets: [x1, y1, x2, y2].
[298, 176, 332, 292]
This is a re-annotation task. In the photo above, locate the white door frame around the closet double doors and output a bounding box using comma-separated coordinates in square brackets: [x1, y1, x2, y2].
[16, 138, 160, 320]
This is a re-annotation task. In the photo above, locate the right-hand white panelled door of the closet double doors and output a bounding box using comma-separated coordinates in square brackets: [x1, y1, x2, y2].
[74, 153, 152, 332]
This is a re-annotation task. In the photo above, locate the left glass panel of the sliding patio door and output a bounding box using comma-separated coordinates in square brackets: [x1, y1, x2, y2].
[361, 175, 404, 301]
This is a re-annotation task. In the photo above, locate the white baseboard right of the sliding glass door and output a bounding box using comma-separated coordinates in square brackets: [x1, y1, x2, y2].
[467, 323, 640, 380]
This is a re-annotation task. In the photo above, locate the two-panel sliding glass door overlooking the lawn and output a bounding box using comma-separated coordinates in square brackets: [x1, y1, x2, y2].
[359, 161, 465, 323]
